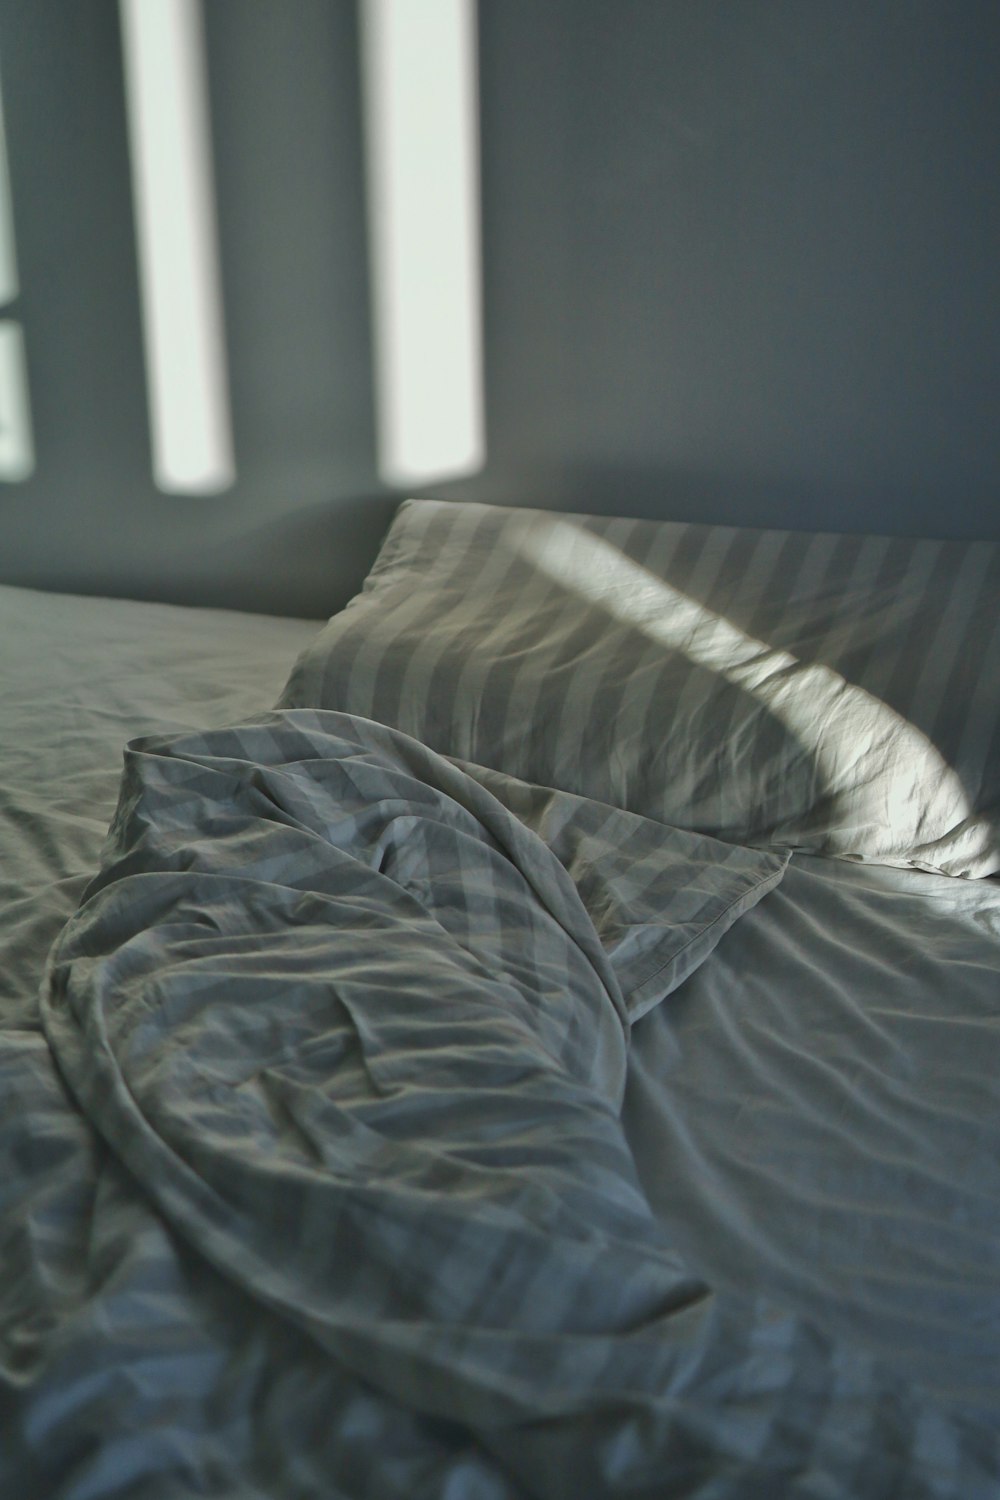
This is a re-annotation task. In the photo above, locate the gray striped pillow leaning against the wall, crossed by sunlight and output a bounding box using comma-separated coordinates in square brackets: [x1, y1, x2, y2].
[279, 500, 1000, 876]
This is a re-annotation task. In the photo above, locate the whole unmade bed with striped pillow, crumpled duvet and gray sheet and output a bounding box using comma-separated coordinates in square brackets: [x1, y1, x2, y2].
[0, 500, 1000, 1500]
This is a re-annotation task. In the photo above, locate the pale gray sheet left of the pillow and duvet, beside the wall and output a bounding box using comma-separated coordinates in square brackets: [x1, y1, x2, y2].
[0, 585, 318, 1022]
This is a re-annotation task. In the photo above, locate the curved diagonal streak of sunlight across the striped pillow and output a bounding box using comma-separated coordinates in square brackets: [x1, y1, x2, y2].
[520, 521, 972, 843]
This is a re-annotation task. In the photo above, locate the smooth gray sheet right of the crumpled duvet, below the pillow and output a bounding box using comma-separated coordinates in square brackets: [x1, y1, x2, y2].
[624, 855, 1000, 1428]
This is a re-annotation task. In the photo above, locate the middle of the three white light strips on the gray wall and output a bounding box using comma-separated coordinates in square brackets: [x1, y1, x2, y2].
[120, 0, 235, 494]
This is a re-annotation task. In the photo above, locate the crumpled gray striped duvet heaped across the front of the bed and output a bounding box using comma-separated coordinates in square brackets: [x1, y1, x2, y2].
[0, 714, 1000, 1500]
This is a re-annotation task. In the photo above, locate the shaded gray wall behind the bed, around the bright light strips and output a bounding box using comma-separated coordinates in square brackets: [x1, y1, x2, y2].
[0, 0, 1000, 615]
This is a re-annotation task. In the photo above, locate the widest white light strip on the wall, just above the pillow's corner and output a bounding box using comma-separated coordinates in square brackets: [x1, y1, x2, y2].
[361, 0, 486, 485]
